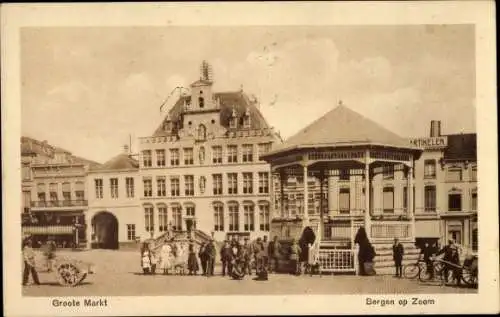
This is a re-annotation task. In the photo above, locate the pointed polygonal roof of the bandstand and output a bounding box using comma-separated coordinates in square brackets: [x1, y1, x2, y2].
[263, 104, 420, 157]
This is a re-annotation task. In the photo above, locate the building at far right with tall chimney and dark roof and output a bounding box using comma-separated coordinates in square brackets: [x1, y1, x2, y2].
[410, 121, 478, 251]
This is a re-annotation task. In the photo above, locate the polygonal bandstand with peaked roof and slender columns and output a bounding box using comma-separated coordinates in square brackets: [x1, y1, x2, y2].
[262, 103, 421, 272]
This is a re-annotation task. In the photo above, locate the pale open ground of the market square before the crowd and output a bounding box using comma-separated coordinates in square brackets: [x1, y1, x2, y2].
[23, 250, 477, 296]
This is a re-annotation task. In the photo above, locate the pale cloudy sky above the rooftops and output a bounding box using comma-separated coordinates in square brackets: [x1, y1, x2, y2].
[21, 25, 476, 163]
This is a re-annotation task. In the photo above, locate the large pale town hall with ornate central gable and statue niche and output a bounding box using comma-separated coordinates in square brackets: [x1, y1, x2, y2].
[139, 62, 281, 240]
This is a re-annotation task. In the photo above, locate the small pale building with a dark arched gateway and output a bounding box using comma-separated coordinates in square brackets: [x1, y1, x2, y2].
[86, 146, 141, 249]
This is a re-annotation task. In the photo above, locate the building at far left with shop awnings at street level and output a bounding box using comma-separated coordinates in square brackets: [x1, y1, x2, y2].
[21, 137, 99, 247]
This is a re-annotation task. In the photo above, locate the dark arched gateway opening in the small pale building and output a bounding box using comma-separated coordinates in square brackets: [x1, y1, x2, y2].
[92, 211, 118, 249]
